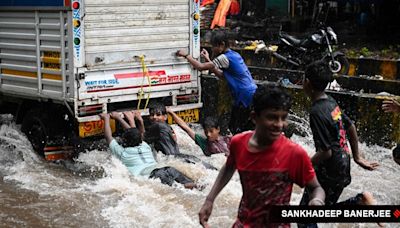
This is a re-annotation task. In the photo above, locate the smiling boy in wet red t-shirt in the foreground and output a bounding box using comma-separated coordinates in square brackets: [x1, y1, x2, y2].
[199, 86, 325, 227]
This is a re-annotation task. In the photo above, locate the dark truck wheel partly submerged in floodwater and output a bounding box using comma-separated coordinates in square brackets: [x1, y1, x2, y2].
[21, 110, 49, 157]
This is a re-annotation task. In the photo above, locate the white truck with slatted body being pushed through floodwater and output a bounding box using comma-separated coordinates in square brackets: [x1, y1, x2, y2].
[0, 0, 202, 157]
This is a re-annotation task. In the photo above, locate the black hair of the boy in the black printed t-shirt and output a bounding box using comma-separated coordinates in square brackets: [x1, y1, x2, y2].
[304, 61, 333, 92]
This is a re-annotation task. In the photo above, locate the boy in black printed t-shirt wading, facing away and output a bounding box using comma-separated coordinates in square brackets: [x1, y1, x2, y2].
[298, 61, 379, 227]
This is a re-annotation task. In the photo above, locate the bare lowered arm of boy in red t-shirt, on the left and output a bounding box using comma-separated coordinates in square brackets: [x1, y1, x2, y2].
[199, 164, 235, 227]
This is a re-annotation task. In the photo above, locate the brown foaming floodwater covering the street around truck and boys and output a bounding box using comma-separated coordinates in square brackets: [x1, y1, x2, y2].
[0, 115, 400, 228]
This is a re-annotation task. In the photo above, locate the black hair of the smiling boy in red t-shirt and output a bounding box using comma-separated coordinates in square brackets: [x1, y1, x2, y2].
[253, 85, 292, 114]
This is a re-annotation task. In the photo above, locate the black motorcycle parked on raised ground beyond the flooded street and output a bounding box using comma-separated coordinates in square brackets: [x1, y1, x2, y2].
[272, 26, 350, 75]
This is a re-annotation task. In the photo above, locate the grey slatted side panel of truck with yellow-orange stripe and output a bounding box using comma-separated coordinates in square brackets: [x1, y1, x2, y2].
[0, 9, 74, 100]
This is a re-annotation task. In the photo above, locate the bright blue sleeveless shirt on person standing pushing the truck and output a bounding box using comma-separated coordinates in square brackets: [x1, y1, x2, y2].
[213, 49, 257, 108]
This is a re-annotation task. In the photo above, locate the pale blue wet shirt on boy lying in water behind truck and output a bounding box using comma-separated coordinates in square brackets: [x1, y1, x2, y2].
[110, 139, 157, 176]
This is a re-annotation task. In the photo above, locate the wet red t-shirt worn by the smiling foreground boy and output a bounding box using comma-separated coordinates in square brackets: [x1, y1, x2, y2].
[227, 131, 315, 227]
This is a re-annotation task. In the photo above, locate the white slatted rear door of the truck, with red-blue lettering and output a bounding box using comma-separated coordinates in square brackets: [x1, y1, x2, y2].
[74, 0, 200, 103]
